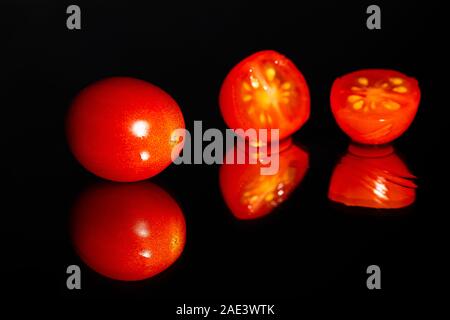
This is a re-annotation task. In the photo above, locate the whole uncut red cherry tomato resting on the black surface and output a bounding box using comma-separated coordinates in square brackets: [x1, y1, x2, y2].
[67, 77, 184, 181]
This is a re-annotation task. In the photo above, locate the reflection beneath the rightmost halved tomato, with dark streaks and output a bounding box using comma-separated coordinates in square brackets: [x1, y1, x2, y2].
[328, 145, 417, 209]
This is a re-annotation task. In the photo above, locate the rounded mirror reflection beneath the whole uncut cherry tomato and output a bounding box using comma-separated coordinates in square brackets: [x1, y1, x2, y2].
[71, 183, 186, 280]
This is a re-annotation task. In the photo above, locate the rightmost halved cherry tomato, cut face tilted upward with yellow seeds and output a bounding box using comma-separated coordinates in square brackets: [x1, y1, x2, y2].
[331, 69, 420, 144]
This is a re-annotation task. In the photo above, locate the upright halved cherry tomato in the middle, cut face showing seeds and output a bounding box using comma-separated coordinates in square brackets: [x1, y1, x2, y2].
[220, 51, 310, 139]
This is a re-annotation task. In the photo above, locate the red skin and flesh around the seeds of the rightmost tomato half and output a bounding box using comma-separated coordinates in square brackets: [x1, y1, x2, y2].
[330, 69, 420, 145]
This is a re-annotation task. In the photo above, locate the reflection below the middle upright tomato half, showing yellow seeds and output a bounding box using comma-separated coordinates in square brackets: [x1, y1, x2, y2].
[219, 145, 308, 220]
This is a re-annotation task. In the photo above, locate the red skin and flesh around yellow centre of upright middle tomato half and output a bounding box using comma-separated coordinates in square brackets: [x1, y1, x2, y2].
[219, 50, 310, 139]
